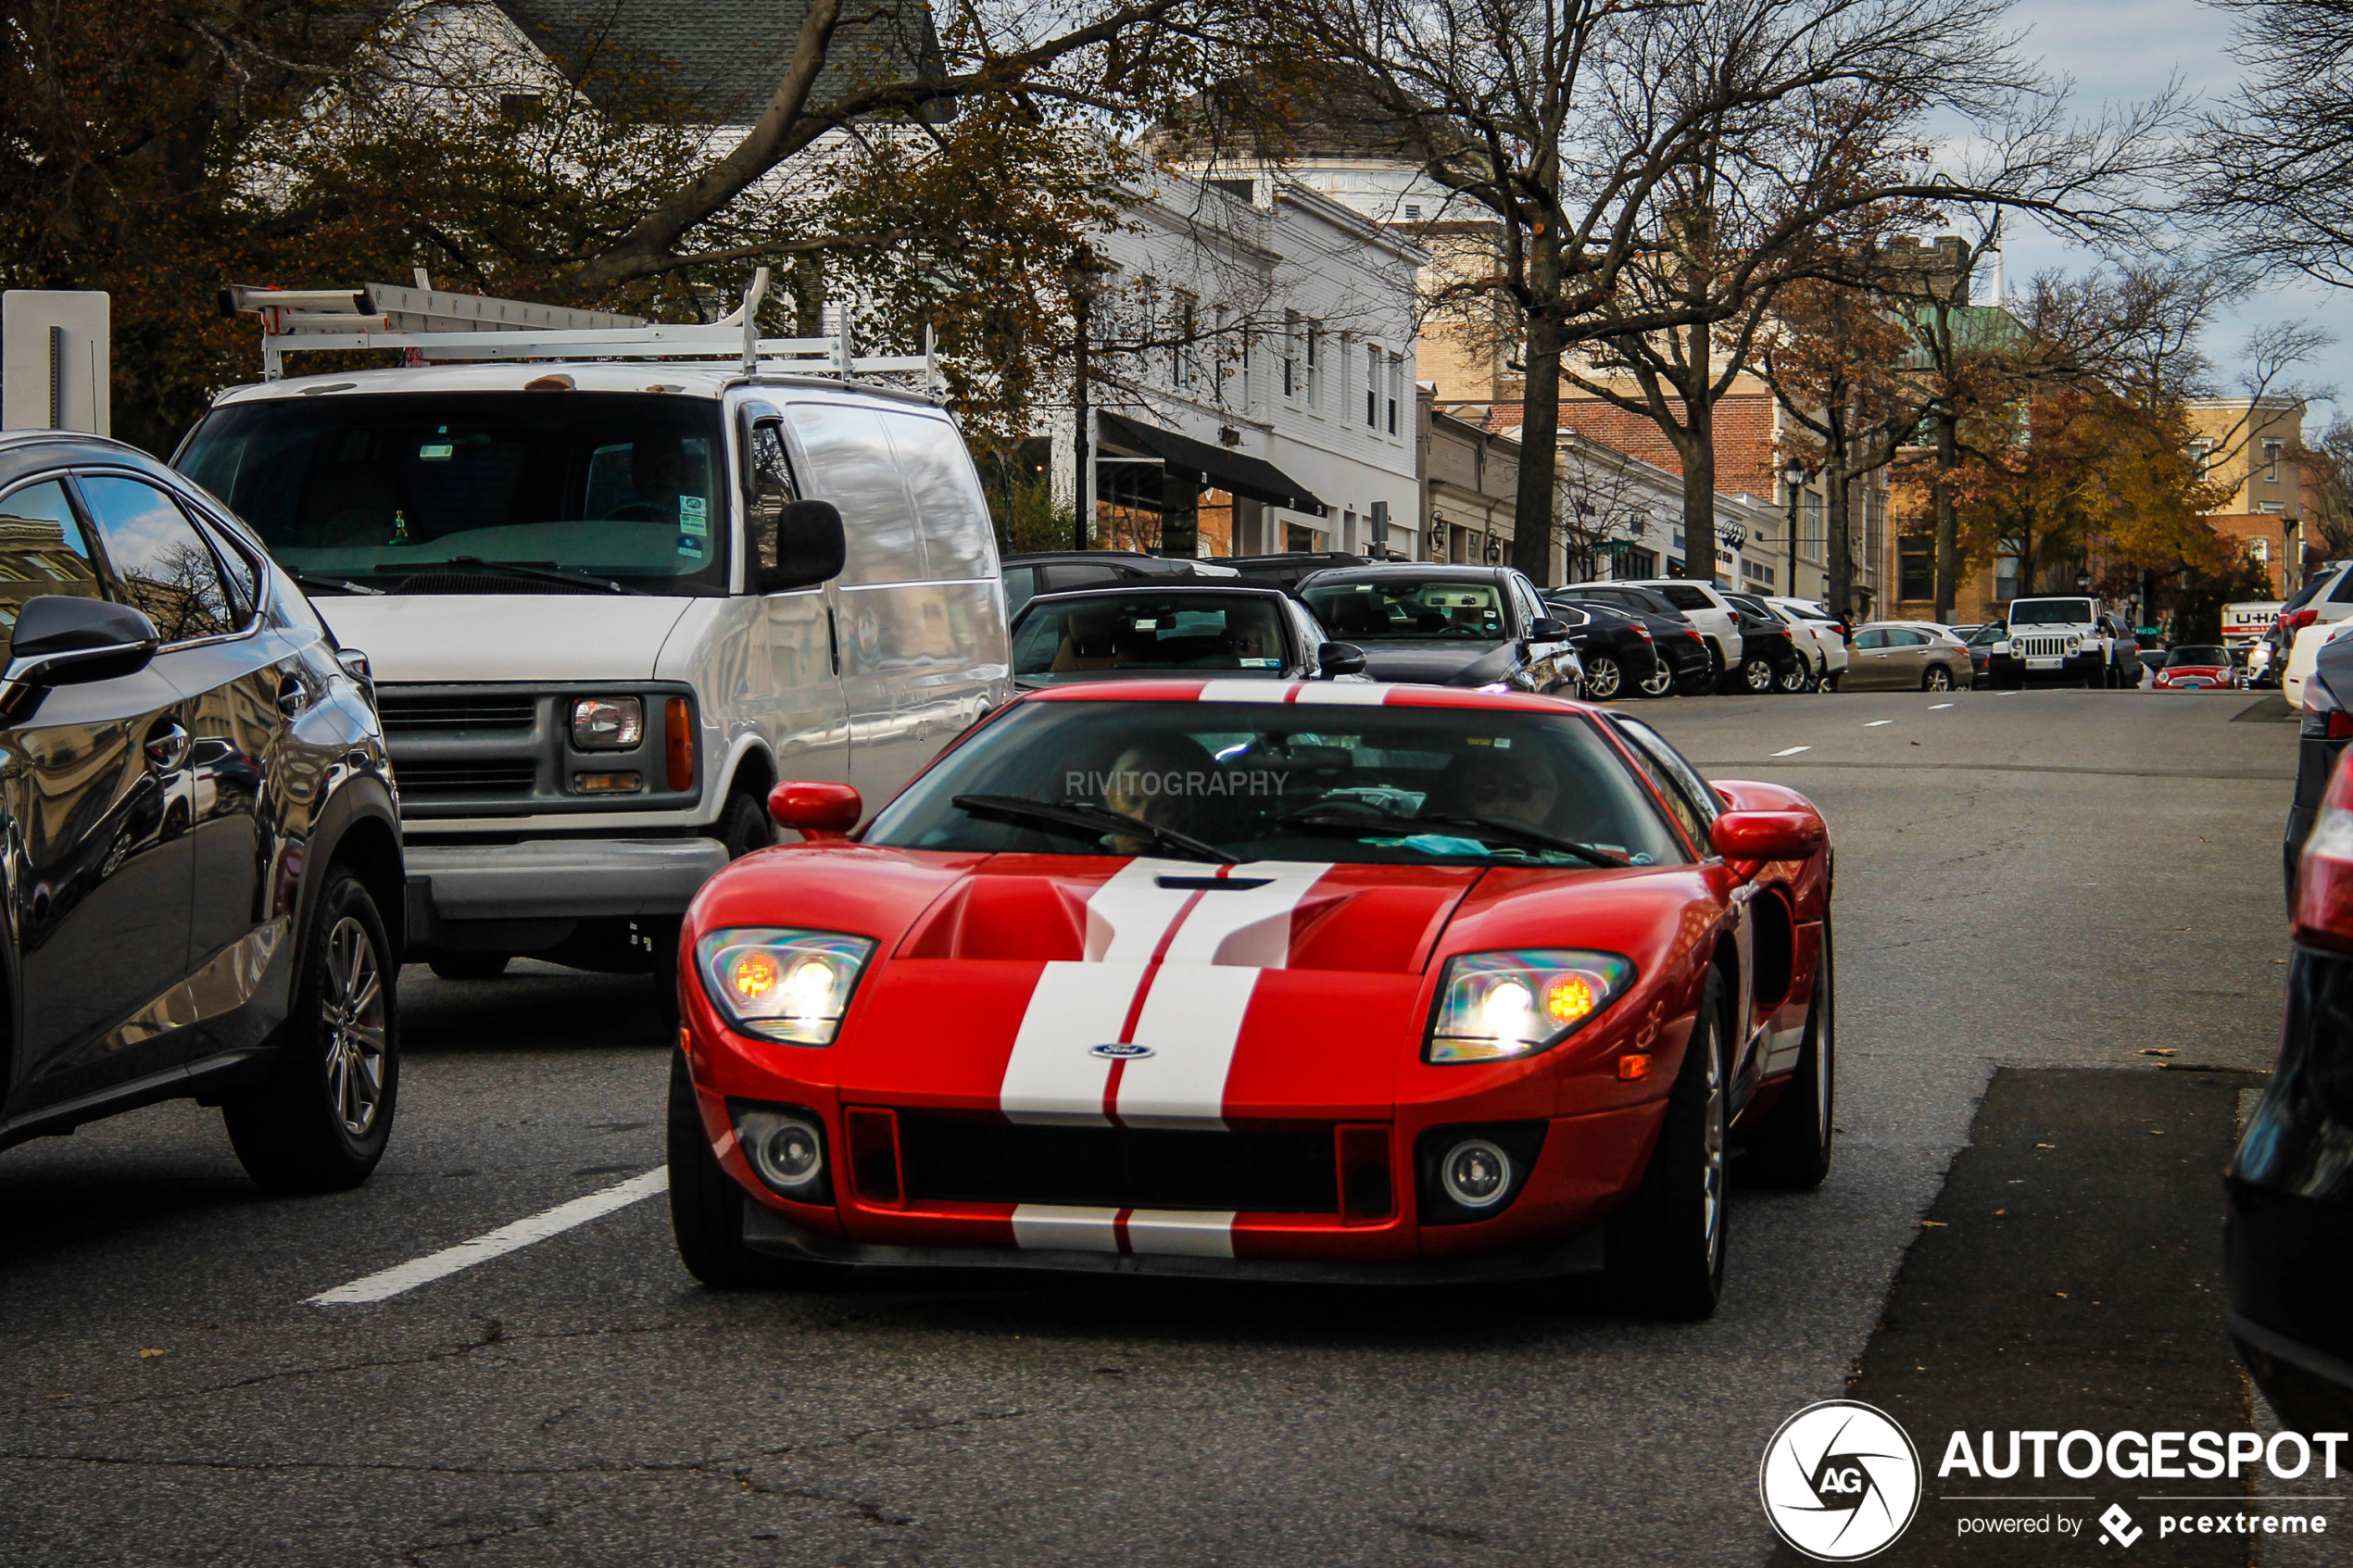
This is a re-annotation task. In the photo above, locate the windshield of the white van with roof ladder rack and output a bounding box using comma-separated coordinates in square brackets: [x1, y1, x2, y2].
[179, 393, 727, 595]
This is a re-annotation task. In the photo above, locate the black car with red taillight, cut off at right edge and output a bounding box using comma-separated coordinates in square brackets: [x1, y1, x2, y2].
[2223, 747, 2353, 1436]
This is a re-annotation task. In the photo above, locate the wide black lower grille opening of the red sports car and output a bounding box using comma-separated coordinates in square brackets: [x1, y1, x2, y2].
[899, 1112, 1339, 1213]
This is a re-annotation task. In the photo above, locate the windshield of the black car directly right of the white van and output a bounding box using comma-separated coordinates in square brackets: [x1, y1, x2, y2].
[1014, 593, 1282, 682]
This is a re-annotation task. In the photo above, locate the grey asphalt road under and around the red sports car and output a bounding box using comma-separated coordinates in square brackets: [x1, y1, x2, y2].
[0, 691, 2306, 1568]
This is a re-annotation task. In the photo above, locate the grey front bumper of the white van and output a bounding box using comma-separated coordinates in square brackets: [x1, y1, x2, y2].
[407, 839, 727, 940]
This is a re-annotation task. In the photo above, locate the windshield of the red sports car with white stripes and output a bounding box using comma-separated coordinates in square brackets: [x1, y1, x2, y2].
[866, 700, 1690, 868]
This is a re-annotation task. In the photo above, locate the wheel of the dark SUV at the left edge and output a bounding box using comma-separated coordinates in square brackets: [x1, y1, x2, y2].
[221, 865, 400, 1192]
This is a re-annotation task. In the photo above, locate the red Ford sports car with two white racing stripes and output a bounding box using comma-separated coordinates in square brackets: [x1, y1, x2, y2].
[668, 680, 1835, 1319]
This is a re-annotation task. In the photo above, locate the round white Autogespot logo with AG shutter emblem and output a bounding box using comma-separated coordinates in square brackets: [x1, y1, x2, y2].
[1757, 1399, 1920, 1563]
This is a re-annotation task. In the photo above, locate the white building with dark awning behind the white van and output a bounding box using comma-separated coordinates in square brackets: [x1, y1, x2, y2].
[1051, 174, 1426, 555]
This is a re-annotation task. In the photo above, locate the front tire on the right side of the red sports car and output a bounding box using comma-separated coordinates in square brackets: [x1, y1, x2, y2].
[1604, 969, 1731, 1321]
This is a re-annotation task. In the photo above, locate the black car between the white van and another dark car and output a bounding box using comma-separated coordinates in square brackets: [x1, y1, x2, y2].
[1012, 581, 1365, 691]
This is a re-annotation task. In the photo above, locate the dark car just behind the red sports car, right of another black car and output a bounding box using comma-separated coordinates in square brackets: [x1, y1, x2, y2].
[1299, 564, 1583, 696]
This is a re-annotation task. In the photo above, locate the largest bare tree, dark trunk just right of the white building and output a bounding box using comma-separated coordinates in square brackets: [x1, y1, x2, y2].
[1271, 0, 2174, 578]
